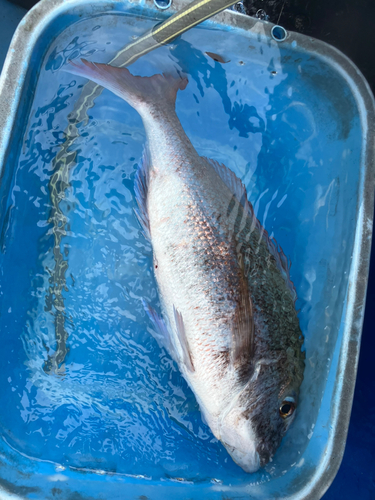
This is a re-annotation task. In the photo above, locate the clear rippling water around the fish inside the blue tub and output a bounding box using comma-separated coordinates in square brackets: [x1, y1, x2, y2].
[0, 10, 359, 484]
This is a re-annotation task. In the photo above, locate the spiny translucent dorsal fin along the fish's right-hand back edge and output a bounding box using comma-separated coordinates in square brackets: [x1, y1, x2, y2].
[202, 156, 297, 302]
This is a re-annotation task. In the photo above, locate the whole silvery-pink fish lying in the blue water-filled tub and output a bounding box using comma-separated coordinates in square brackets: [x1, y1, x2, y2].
[69, 59, 305, 473]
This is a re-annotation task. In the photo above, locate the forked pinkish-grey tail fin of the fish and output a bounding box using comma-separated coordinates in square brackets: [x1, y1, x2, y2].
[68, 59, 188, 112]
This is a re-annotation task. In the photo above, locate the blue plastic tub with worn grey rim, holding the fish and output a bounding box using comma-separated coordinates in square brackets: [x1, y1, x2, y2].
[0, 1, 374, 499]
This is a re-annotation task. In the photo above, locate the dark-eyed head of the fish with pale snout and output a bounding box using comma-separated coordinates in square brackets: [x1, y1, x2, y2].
[219, 352, 303, 473]
